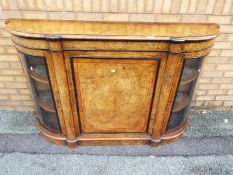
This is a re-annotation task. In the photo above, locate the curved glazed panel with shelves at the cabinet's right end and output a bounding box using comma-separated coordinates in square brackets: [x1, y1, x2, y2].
[164, 57, 203, 139]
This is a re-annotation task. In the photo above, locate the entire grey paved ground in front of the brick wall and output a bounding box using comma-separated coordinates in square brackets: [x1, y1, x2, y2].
[0, 111, 233, 175]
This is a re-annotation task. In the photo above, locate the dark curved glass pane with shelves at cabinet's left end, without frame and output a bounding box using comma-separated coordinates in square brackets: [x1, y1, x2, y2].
[20, 53, 61, 134]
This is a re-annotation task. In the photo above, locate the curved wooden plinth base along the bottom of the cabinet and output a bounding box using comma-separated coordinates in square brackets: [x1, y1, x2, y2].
[37, 116, 188, 148]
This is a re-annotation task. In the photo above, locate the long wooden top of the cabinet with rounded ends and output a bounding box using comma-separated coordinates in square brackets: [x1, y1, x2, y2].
[6, 19, 219, 42]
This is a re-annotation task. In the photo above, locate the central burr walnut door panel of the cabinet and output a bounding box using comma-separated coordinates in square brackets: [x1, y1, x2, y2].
[71, 53, 158, 133]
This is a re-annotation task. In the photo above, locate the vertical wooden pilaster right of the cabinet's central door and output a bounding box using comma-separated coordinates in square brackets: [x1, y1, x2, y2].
[151, 38, 184, 146]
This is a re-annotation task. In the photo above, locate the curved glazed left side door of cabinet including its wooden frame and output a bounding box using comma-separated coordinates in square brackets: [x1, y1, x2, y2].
[14, 45, 65, 135]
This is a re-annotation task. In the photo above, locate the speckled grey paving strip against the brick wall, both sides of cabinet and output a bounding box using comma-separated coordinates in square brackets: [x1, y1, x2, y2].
[0, 110, 233, 137]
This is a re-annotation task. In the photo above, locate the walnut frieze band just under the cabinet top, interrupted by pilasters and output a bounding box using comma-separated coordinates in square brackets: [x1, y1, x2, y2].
[12, 35, 214, 52]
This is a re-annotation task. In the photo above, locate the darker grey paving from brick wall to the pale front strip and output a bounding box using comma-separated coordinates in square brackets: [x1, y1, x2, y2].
[0, 111, 233, 156]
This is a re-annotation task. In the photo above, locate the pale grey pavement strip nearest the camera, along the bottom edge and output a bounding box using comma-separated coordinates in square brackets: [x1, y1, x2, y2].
[0, 153, 233, 175]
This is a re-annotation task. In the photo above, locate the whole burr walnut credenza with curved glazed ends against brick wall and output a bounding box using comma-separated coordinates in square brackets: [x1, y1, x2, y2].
[6, 19, 219, 147]
